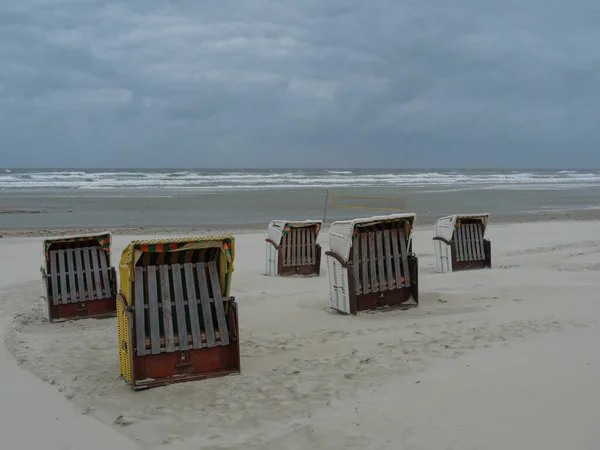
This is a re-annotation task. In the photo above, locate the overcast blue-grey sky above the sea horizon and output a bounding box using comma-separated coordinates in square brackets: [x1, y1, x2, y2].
[0, 0, 600, 168]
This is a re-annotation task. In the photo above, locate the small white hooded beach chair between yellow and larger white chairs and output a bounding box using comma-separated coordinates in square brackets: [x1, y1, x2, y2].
[265, 220, 323, 276]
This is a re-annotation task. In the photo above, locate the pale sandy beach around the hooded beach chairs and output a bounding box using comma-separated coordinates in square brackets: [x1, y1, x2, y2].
[0, 217, 600, 450]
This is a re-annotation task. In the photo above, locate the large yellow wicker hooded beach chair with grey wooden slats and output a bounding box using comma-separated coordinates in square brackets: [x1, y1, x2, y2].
[117, 235, 240, 389]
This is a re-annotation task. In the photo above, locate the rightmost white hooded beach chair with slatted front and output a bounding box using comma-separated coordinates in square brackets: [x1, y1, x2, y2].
[433, 214, 492, 273]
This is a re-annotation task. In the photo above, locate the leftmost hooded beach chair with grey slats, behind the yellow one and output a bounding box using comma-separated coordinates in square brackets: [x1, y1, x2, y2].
[41, 233, 117, 322]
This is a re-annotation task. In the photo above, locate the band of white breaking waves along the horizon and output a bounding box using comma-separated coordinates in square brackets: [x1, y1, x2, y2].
[0, 169, 600, 191]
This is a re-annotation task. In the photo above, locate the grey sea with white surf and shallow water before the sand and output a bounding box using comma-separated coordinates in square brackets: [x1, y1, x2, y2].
[0, 168, 600, 229]
